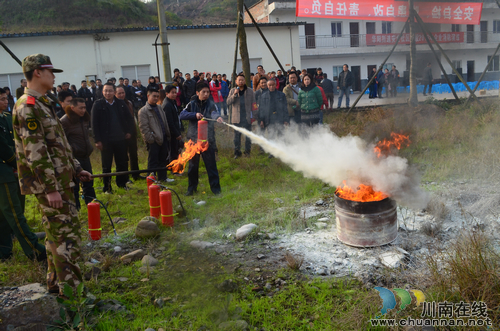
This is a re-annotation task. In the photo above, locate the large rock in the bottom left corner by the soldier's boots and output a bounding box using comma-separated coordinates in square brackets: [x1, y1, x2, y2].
[0, 283, 59, 330]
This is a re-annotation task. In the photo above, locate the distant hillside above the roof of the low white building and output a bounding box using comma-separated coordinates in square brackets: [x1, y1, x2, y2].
[0, 0, 264, 33]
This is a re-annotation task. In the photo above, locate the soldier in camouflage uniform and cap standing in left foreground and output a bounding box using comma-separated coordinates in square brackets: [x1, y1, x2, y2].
[12, 54, 90, 295]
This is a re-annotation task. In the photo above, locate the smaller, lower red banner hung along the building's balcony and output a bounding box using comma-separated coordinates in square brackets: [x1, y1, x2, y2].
[366, 32, 464, 46]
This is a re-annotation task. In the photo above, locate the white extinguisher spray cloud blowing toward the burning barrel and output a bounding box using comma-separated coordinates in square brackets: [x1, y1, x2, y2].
[231, 125, 428, 208]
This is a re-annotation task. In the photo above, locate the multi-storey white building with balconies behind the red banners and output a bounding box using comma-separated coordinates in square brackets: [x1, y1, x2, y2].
[245, 0, 500, 90]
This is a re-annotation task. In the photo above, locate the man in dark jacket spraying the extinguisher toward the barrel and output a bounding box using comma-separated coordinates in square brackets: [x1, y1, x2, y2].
[179, 83, 223, 196]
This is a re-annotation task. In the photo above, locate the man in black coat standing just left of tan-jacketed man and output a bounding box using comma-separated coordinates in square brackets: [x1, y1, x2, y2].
[92, 83, 136, 193]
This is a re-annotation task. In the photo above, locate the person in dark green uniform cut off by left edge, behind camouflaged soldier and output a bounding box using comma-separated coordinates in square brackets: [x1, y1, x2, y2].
[0, 88, 47, 261]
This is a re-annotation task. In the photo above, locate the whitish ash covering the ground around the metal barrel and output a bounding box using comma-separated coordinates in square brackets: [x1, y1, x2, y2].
[278, 182, 500, 287]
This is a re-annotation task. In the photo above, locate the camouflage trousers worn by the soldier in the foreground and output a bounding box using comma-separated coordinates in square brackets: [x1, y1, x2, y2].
[36, 187, 83, 294]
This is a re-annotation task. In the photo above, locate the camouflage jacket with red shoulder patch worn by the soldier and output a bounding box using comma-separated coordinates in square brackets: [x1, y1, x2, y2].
[12, 88, 82, 194]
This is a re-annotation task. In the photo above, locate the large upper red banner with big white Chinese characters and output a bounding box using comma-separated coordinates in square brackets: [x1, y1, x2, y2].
[295, 0, 483, 25]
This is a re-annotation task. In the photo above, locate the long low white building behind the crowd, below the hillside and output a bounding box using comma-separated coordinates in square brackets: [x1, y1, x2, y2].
[0, 22, 303, 90]
